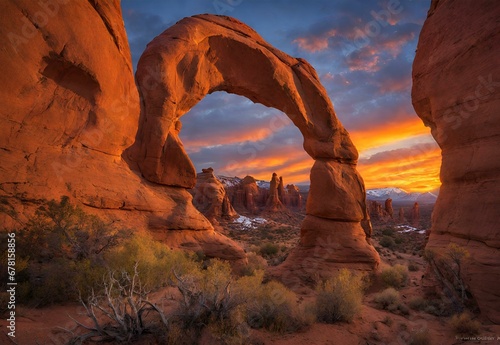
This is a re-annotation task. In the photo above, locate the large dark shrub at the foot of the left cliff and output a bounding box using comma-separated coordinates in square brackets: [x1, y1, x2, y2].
[11, 197, 129, 306]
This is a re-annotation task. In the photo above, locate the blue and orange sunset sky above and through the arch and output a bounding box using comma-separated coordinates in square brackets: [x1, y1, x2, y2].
[122, 0, 441, 191]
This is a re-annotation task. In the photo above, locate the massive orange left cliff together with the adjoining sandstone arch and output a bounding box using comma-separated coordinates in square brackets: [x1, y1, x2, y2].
[0, 8, 379, 277]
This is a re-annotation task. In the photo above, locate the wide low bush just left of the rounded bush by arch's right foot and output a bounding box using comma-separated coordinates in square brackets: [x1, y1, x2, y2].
[234, 271, 314, 333]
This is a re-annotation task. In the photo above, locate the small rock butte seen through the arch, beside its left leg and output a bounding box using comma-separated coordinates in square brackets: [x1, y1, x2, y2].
[193, 168, 238, 224]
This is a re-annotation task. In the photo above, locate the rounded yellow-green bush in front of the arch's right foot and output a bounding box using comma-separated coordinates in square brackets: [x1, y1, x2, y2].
[316, 269, 363, 323]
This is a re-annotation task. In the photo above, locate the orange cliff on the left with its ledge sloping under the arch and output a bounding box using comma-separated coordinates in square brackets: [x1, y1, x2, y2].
[0, 0, 245, 260]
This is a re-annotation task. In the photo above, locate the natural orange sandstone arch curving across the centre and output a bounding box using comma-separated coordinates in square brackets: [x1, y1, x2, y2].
[131, 15, 379, 280]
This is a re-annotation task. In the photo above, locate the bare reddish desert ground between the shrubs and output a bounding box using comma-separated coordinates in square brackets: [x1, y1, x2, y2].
[4, 206, 500, 345]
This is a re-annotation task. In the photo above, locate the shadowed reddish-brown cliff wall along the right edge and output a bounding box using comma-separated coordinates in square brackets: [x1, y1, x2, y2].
[412, 0, 500, 323]
